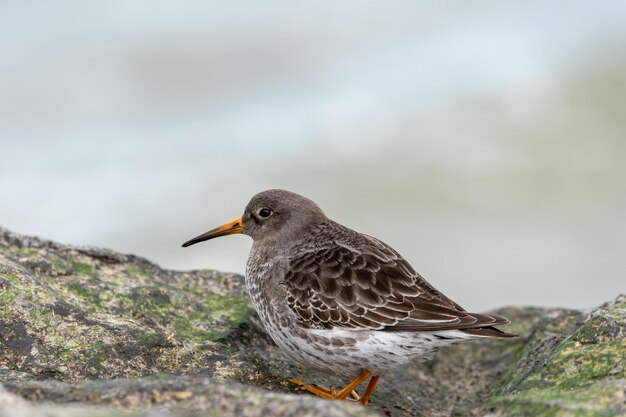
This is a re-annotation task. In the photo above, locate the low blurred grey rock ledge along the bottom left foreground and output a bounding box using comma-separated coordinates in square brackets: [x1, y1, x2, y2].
[0, 375, 376, 417]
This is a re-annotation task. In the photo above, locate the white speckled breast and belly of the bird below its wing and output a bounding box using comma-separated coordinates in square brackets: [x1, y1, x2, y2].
[246, 239, 477, 379]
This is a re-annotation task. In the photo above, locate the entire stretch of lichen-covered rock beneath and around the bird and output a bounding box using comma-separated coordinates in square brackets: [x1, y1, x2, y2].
[0, 229, 626, 417]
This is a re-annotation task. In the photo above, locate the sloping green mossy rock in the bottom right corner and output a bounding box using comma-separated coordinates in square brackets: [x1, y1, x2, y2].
[483, 299, 626, 417]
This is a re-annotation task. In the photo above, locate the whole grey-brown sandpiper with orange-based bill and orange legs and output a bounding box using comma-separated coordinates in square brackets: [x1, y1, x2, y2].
[183, 189, 516, 406]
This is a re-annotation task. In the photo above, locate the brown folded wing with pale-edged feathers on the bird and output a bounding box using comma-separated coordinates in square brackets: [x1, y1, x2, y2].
[285, 237, 509, 335]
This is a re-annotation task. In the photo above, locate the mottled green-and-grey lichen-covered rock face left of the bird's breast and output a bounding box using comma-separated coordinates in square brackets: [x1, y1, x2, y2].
[0, 226, 256, 382]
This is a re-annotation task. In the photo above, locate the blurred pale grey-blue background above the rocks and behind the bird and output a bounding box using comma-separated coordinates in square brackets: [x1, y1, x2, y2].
[0, 0, 626, 310]
